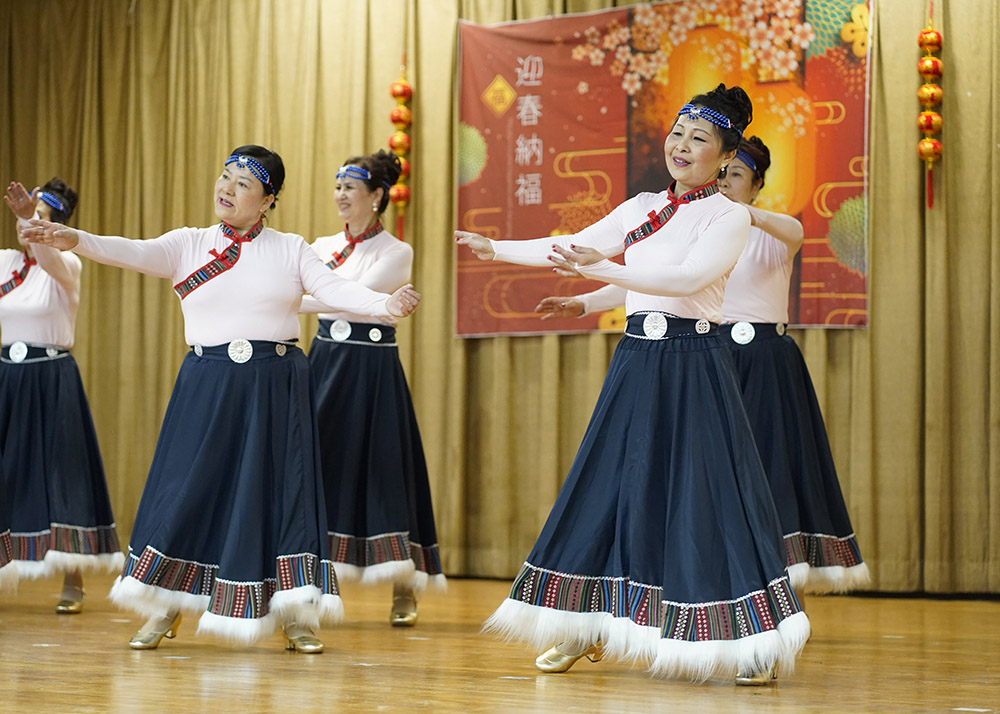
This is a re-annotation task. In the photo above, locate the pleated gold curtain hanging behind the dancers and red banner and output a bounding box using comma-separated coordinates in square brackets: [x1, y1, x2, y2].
[0, 0, 1000, 593]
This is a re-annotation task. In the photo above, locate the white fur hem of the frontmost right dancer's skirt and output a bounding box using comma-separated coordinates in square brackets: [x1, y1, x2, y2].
[483, 599, 809, 682]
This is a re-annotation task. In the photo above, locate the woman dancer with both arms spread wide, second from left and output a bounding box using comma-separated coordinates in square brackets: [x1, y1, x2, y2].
[21, 145, 419, 653]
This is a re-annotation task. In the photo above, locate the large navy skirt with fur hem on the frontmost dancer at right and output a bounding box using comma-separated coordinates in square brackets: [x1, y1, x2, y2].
[487, 314, 809, 680]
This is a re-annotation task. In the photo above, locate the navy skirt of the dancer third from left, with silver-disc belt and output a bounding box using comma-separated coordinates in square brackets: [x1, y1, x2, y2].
[309, 320, 444, 591]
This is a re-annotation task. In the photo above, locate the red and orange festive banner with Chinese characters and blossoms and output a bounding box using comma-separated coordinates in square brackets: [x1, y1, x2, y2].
[456, 0, 869, 336]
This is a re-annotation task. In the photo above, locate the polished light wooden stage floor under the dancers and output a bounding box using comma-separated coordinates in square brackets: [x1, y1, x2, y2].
[0, 576, 1000, 714]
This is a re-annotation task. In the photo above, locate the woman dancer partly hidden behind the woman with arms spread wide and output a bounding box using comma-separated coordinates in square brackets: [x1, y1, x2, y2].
[302, 151, 445, 627]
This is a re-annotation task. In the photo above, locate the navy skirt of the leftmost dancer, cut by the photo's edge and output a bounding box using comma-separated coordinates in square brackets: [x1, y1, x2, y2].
[0, 343, 122, 577]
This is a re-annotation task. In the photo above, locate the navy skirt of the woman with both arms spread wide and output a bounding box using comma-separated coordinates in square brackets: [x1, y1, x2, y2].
[111, 342, 341, 644]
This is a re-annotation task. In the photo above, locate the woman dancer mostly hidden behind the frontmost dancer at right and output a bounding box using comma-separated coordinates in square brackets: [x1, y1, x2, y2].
[537, 136, 869, 593]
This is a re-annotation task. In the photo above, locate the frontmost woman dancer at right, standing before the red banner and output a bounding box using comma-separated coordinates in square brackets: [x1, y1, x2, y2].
[456, 85, 809, 684]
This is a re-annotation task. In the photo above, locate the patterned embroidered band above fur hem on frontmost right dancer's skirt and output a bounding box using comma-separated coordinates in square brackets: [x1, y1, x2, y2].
[509, 563, 802, 642]
